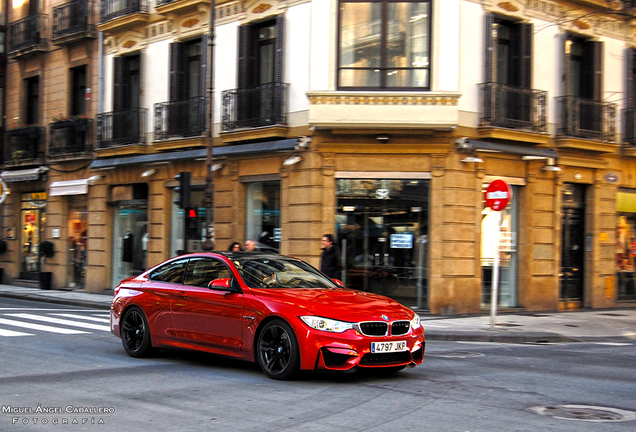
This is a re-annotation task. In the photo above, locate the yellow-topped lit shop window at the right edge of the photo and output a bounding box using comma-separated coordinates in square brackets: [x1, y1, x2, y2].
[616, 190, 636, 300]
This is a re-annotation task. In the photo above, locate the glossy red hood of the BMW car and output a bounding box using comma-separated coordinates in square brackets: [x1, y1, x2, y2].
[254, 288, 414, 322]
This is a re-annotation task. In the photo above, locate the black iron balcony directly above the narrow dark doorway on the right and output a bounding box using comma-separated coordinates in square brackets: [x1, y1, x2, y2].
[556, 96, 616, 152]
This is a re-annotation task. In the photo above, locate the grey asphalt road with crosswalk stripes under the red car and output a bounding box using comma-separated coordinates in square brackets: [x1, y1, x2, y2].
[0, 299, 636, 432]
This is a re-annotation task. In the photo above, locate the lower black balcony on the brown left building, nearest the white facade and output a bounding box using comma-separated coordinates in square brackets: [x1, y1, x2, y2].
[48, 118, 93, 160]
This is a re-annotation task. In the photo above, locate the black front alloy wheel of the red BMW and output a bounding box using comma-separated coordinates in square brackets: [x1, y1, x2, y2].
[257, 320, 300, 380]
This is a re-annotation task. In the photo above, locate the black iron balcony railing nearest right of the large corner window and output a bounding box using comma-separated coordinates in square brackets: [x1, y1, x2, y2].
[479, 82, 548, 132]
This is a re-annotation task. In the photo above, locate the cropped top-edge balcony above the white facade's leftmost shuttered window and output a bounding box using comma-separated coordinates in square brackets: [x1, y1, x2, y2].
[98, 0, 150, 32]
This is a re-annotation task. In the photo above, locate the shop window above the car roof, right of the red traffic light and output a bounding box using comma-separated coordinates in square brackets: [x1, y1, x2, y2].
[245, 180, 281, 251]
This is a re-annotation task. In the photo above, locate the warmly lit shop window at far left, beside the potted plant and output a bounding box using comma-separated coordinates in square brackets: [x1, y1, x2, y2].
[20, 192, 47, 279]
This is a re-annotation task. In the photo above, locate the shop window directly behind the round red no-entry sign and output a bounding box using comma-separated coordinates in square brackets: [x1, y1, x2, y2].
[481, 184, 520, 307]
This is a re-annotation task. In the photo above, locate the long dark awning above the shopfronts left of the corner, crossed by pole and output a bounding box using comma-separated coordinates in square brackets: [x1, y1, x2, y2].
[91, 138, 298, 169]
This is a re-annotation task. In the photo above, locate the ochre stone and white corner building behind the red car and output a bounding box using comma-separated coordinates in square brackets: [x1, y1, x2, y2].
[2, 0, 636, 314]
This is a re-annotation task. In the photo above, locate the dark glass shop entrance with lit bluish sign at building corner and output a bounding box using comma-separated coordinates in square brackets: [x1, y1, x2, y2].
[337, 179, 429, 308]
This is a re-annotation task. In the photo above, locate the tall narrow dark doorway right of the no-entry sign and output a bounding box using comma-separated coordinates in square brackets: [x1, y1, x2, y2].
[560, 184, 585, 306]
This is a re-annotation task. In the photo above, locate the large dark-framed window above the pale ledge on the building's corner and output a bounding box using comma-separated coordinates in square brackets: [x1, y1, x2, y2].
[337, 0, 431, 90]
